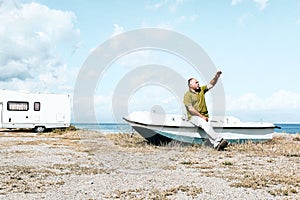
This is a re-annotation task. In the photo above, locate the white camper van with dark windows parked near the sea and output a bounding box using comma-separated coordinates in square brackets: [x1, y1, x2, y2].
[0, 90, 71, 132]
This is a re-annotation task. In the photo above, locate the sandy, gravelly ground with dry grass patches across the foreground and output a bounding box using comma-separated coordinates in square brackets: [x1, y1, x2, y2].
[0, 130, 300, 200]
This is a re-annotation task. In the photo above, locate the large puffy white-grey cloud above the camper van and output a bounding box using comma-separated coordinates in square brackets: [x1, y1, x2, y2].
[0, 1, 80, 92]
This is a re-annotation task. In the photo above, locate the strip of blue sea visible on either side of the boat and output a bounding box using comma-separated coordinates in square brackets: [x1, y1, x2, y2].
[72, 123, 300, 134]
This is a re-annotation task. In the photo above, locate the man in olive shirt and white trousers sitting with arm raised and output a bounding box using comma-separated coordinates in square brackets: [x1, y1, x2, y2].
[183, 71, 228, 151]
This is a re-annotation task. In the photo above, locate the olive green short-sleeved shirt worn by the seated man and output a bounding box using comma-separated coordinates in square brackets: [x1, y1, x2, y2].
[183, 85, 208, 119]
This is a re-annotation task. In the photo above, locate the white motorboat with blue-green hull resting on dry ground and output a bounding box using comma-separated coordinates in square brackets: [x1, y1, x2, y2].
[123, 111, 280, 145]
